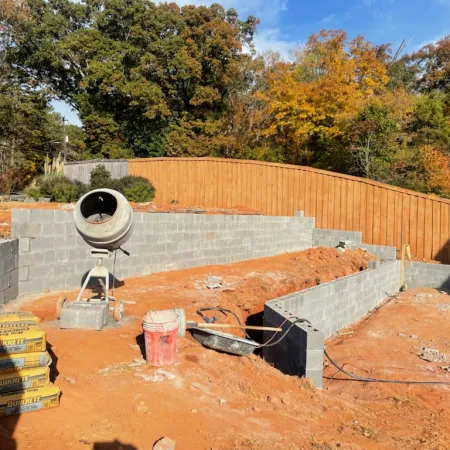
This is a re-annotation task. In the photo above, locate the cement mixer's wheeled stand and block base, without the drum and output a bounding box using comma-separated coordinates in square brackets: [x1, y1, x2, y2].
[56, 248, 124, 330]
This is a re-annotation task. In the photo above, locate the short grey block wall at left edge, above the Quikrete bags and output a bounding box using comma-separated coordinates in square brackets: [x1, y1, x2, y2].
[0, 239, 19, 305]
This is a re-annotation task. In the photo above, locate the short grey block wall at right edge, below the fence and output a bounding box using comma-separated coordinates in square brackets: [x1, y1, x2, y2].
[405, 261, 450, 290]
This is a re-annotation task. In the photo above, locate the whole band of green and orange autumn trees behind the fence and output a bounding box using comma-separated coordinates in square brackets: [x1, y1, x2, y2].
[0, 0, 450, 196]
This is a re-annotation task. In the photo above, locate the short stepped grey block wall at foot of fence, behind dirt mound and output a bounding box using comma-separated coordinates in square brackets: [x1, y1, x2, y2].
[313, 228, 397, 261]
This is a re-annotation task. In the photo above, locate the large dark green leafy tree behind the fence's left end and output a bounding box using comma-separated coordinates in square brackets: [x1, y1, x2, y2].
[9, 0, 257, 157]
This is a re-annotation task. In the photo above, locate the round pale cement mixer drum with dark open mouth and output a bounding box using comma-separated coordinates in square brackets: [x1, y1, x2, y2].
[74, 189, 133, 251]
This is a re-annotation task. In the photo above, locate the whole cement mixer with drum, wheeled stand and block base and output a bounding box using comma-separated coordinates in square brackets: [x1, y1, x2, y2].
[56, 189, 133, 330]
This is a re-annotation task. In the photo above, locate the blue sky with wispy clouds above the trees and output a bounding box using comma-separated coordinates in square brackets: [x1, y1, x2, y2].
[54, 0, 450, 125]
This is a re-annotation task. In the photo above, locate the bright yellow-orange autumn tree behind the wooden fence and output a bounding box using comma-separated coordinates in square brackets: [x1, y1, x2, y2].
[258, 30, 388, 164]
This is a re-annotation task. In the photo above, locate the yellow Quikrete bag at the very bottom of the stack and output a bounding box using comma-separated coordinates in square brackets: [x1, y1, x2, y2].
[0, 383, 60, 417]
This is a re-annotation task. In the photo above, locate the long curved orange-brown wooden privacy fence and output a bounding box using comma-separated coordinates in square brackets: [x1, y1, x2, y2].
[128, 158, 450, 262]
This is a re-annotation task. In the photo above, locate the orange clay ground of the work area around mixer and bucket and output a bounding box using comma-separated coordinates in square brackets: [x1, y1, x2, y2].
[0, 248, 450, 450]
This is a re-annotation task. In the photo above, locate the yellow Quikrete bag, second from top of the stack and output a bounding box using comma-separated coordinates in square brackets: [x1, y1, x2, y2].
[0, 325, 46, 355]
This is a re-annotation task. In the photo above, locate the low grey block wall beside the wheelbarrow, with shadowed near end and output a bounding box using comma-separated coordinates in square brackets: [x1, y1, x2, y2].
[263, 261, 400, 387]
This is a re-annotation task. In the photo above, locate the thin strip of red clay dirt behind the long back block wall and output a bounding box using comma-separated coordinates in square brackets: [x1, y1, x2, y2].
[0, 202, 260, 237]
